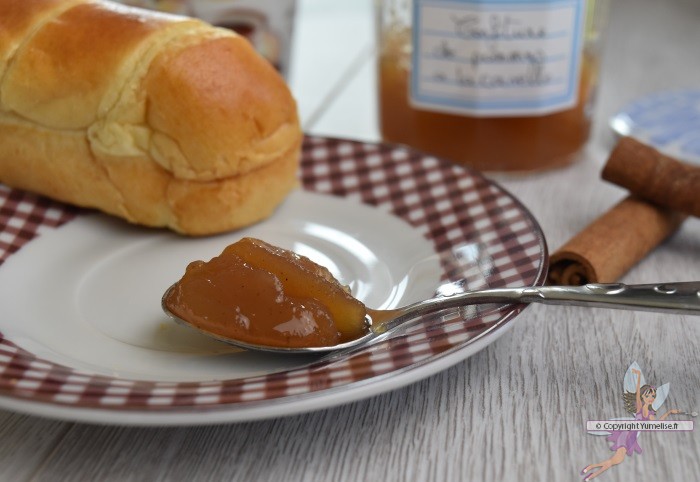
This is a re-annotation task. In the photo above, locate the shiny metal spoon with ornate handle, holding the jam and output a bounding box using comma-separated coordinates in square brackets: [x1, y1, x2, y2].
[162, 281, 700, 354]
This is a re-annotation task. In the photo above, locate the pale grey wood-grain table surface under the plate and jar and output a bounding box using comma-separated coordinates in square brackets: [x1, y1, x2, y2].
[0, 0, 700, 481]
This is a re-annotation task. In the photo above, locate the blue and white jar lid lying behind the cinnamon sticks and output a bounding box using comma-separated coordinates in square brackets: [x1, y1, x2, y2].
[610, 90, 700, 164]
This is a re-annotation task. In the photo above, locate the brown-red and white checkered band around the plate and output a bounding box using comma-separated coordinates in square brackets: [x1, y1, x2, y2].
[0, 137, 547, 413]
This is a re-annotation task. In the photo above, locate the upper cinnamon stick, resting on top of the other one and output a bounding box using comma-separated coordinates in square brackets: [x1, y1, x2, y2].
[602, 137, 700, 216]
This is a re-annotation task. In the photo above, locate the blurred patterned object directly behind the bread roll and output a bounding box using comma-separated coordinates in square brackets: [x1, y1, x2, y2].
[117, 0, 296, 76]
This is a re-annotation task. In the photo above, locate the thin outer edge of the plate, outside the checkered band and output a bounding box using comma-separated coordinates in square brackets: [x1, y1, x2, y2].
[0, 137, 548, 425]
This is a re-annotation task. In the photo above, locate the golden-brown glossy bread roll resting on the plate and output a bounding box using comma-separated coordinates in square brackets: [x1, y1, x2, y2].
[0, 0, 302, 235]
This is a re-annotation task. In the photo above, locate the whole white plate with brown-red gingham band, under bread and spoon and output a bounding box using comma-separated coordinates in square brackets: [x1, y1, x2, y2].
[0, 138, 546, 425]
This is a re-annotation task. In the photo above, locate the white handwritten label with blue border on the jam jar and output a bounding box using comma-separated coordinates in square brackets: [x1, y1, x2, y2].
[411, 0, 585, 116]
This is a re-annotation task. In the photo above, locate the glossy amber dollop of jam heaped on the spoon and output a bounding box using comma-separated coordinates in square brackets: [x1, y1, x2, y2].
[163, 238, 368, 348]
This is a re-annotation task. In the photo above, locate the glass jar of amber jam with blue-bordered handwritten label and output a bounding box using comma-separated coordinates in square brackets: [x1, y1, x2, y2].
[377, 0, 608, 172]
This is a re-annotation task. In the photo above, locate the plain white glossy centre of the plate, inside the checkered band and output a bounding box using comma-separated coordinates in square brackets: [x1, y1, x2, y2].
[0, 190, 441, 382]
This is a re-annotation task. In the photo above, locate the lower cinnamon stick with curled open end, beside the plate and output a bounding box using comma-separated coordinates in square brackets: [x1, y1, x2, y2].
[549, 196, 686, 285]
